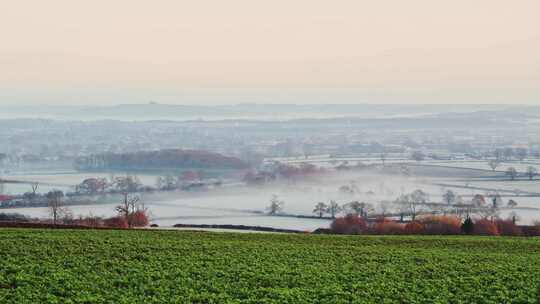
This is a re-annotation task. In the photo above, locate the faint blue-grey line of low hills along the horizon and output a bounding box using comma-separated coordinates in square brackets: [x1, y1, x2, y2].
[0, 103, 540, 121]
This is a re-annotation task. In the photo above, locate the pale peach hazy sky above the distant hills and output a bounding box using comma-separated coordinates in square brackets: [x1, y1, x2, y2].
[0, 0, 540, 105]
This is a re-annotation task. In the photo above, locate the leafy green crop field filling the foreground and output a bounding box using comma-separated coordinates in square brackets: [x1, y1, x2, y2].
[0, 229, 540, 303]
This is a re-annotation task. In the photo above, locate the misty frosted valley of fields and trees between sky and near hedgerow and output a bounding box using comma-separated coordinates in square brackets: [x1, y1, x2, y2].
[0, 103, 540, 231]
